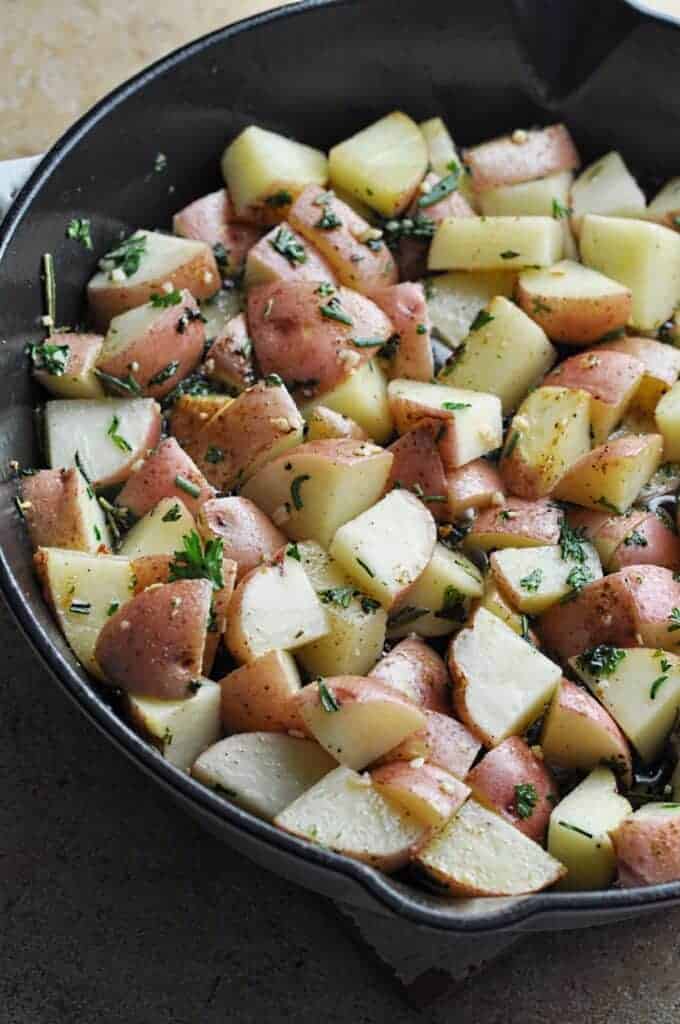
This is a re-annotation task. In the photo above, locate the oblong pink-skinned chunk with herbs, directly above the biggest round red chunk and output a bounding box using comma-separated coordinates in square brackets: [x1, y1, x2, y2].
[289, 185, 398, 294]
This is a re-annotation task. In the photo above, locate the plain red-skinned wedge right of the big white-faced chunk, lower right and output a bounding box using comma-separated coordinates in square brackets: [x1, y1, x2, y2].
[541, 679, 633, 786]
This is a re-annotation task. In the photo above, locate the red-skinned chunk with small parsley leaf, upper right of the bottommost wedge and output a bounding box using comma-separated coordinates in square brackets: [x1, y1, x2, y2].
[465, 736, 559, 843]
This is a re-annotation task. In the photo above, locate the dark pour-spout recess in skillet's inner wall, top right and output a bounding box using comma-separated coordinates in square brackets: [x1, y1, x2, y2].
[510, 0, 646, 102]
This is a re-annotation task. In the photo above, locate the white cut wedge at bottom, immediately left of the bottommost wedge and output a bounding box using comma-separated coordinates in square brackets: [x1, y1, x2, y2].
[192, 732, 336, 821]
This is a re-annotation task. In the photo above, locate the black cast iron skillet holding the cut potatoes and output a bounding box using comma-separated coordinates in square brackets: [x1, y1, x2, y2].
[0, 0, 680, 933]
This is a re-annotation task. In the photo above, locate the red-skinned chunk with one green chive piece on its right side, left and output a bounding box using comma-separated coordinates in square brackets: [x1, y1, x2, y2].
[116, 437, 215, 518]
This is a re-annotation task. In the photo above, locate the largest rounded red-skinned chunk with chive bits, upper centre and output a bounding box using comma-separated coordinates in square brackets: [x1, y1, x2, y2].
[248, 282, 393, 398]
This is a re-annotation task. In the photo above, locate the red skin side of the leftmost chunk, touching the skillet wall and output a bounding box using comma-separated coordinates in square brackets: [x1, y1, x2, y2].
[22, 468, 108, 552]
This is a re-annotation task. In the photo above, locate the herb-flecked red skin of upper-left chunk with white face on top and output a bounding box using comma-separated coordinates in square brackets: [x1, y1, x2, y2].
[97, 290, 206, 398]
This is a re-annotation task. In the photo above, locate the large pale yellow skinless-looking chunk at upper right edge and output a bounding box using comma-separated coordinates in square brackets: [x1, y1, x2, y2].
[581, 214, 680, 331]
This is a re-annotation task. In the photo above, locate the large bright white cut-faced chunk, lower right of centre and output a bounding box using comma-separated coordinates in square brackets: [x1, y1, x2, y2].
[449, 608, 562, 746]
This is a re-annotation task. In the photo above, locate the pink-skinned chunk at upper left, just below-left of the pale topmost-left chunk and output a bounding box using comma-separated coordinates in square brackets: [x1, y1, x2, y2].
[172, 188, 260, 274]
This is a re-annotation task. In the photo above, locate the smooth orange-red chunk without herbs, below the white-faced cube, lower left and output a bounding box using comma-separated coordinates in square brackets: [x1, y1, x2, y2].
[219, 650, 304, 732]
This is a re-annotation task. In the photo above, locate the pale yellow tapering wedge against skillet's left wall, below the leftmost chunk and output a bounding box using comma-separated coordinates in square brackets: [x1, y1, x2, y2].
[37, 548, 133, 679]
